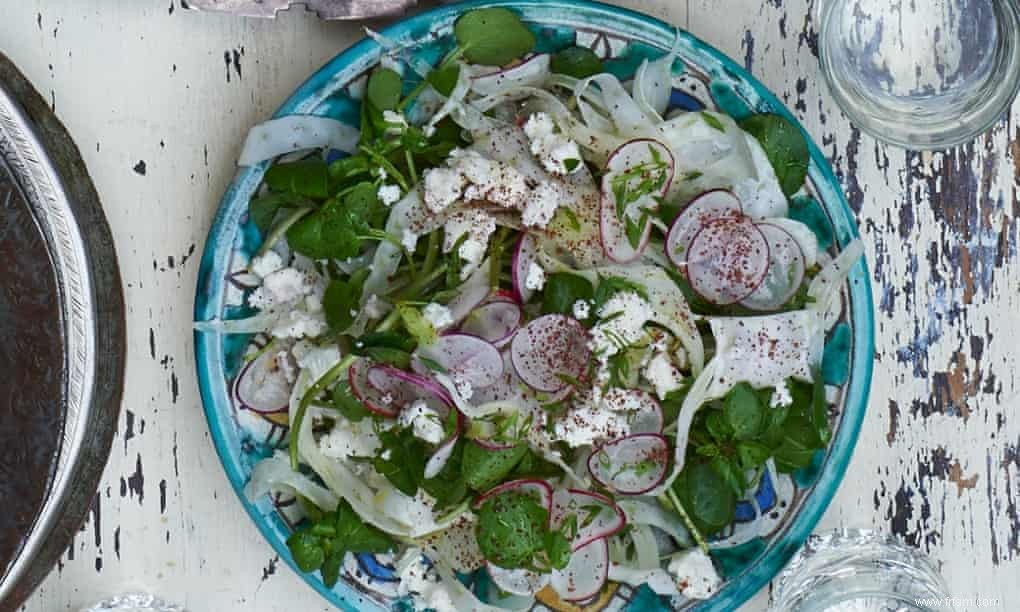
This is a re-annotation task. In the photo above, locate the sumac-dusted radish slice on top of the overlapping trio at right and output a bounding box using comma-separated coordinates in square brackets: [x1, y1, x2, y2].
[686, 217, 769, 306]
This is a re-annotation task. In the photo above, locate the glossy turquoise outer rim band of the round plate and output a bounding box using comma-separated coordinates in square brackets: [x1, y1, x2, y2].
[195, 0, 874, 612]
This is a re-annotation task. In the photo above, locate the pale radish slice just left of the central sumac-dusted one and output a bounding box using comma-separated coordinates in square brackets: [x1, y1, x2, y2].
[411, 334, 503, 389]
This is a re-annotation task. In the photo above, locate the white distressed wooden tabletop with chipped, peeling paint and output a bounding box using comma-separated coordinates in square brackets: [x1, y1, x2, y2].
[0, 0, 1020, 612]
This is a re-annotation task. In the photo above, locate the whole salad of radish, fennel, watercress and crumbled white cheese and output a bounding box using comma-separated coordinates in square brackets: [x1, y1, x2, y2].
[198, 8, 862, 611]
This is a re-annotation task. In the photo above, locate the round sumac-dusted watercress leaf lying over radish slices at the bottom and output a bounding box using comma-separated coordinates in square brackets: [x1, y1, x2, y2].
[477, 487, 549, 569]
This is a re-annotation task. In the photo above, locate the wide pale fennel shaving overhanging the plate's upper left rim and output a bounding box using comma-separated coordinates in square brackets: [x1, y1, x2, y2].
[238, 115, 360, 166]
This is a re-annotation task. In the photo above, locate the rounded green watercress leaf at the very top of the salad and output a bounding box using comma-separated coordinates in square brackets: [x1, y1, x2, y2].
[453, 7, 534, 66]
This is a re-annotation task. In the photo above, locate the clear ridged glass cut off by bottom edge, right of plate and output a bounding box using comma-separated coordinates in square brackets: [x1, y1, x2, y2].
[770, 529, 954, 612]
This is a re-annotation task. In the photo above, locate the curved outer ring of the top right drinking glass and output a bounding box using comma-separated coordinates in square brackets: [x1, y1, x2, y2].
[815, 0, 1020, 150]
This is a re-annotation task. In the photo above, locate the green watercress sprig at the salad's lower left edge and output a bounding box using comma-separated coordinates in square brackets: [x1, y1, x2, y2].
[287, 501, 395, 588]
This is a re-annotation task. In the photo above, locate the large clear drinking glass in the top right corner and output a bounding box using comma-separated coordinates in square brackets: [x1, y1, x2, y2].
[816, 0, 1020, 149]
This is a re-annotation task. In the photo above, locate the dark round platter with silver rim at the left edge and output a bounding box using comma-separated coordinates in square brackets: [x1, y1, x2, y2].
[0, 54, 124, 610]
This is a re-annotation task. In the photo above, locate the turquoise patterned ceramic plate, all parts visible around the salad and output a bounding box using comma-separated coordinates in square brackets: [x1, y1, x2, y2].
[195, 0, 874, 611]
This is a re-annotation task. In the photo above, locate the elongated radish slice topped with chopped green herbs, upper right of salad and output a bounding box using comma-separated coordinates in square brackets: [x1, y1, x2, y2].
[599, 139, 676, 263]
